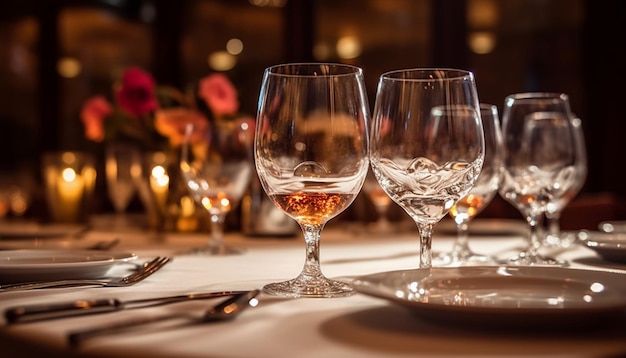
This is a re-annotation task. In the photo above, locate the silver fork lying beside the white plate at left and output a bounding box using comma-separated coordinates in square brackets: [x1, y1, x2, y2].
[0, 256, 172, 292]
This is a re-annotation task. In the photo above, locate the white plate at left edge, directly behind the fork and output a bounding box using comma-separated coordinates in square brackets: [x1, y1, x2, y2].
[0, 250, 137, 283]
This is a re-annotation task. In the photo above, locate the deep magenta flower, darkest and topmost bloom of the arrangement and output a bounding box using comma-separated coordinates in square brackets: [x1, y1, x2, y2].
[116, 67, 158, 117]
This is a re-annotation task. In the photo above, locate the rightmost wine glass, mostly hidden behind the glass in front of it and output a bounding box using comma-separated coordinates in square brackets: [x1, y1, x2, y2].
[543, 117, 587, 248]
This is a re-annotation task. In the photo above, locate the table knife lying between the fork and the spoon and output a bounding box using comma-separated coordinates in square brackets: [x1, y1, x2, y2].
[4, 291, 248, 323]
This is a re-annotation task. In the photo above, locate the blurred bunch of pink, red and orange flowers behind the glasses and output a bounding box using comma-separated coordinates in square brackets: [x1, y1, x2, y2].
[80, 67, 254, 149]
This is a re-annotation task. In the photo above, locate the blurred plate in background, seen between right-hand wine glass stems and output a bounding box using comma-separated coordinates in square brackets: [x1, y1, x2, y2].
[435, 218, 528, 236]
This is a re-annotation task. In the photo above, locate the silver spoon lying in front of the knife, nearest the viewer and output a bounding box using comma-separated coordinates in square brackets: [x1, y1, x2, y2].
[68, 289, 261, 348]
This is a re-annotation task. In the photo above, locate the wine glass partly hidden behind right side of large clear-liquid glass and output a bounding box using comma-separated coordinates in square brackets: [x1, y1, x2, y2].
[434, 103, 502, 266]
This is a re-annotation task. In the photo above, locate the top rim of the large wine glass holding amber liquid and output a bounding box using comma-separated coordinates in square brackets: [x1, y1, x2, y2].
[265, 62, 363, 78]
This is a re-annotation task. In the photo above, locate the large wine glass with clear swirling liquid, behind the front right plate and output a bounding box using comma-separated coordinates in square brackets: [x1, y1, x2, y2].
[370, 68, 485, 268]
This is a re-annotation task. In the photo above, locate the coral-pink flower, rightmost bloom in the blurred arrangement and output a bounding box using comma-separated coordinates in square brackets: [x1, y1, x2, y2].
[198, 73, 239, 116]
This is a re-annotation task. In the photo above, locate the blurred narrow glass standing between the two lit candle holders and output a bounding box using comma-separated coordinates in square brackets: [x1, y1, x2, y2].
[104, 143, 141, 217]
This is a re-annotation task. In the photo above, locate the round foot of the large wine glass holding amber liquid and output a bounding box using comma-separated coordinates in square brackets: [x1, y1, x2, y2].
[263, 276, 356, 298]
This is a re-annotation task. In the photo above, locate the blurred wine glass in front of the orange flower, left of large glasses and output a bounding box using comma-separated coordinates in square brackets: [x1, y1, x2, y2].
[180, 120, 254, 255]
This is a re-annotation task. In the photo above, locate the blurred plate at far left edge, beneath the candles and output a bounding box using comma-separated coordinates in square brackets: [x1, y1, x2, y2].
[0, 222, 86, 239]
